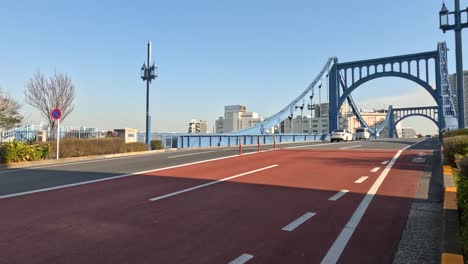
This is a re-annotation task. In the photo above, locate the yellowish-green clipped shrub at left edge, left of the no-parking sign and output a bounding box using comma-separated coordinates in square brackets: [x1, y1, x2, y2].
[0, 141, 50, 163]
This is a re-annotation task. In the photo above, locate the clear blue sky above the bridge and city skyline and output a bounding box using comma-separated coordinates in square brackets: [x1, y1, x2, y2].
[0, 0, 468, 132]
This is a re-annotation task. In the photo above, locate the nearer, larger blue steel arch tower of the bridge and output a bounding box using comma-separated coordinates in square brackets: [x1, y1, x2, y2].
[328, 42, 456, 135]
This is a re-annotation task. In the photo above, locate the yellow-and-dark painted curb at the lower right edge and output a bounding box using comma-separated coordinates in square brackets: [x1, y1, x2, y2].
[441, 165, 464, 264]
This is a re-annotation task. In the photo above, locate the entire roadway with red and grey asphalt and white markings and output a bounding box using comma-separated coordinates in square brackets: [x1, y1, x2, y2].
[0, 139, 438, 263]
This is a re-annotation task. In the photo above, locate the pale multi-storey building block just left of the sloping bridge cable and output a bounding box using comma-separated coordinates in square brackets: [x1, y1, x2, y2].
[215, 105, 263, 133]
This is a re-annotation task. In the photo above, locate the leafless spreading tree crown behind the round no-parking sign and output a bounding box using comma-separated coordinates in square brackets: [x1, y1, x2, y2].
[24, 71, 75, 126]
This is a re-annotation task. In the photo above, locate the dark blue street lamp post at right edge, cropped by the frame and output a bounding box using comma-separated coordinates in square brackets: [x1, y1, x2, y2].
[439, 0, 468, 128]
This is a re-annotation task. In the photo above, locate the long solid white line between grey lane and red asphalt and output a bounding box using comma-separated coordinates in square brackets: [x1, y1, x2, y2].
[0, 150, 267, 199]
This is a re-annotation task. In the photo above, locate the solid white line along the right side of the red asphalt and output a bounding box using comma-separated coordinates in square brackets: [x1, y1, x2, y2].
[321, 150, 403, 264]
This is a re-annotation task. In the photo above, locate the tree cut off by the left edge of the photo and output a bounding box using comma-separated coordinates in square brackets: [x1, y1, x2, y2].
[0, 89, 23, 129]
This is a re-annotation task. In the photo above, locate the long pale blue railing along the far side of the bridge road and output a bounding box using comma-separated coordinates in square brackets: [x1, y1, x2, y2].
[138, 133, 328, 148]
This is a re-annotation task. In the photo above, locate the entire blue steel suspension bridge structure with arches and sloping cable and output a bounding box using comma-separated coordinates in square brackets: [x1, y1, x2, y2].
[233, 42, 458, 137]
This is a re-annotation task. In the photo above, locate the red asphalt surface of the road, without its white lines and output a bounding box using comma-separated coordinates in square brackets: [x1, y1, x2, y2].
[0, 150, 432, 263]
